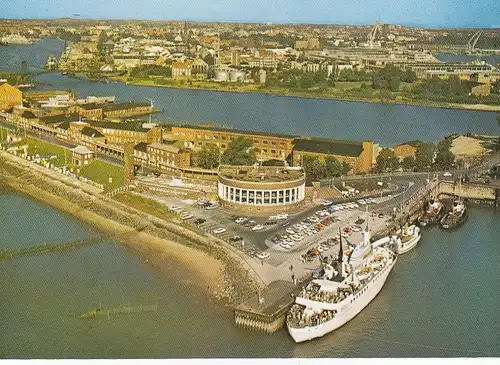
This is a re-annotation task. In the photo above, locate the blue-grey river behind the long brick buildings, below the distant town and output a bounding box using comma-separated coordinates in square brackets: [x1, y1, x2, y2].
[0, 40, 498, 145]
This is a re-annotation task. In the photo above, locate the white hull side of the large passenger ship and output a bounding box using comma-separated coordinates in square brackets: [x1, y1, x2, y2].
[287, 259, 397, 343]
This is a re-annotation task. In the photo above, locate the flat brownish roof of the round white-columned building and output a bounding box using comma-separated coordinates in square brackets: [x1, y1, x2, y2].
[219, 165, 304, 182]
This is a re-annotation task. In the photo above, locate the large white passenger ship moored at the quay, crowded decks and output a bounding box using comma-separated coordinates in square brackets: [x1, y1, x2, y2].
[287, 227, 397, 342]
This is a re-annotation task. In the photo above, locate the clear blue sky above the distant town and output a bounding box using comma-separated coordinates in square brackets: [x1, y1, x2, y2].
[0, 0, 500, 28]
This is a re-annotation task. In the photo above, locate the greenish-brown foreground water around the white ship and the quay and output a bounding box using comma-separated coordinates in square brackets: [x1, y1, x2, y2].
[0, 183, 500, 358]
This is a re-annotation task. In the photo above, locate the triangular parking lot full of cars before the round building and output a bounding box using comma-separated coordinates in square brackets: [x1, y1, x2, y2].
[141, 195, 387, 266]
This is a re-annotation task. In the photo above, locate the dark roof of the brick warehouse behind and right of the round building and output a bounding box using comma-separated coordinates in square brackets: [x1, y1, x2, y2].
[293, 138, 363, 157]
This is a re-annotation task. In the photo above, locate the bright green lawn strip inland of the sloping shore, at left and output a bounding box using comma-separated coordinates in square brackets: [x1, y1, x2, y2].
[0, 129, 123, 192]
